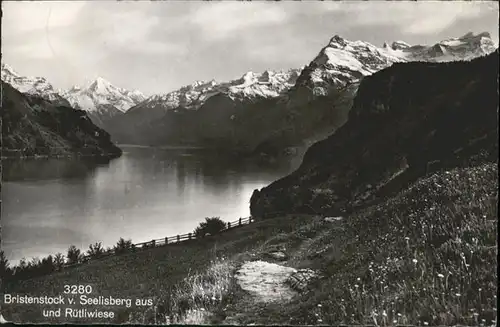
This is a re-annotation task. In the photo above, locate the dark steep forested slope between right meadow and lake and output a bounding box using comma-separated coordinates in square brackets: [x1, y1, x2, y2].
[251, 50, 498, 217]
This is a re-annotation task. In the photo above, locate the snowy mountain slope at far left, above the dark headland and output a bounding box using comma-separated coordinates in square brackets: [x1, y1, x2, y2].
[2, 63, 69, 106]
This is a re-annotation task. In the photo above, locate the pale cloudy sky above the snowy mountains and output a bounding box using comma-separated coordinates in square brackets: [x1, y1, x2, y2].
[2, 1, 498, 95]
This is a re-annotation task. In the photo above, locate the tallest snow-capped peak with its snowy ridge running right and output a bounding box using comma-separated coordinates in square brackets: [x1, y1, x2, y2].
[295, 32, 496, 96]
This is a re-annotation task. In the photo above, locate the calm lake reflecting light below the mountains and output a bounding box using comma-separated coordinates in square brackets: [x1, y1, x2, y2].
[1, 147, 296, 264]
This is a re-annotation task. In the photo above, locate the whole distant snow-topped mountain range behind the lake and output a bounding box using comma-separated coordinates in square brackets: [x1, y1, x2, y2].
[2, 33, 495, 158]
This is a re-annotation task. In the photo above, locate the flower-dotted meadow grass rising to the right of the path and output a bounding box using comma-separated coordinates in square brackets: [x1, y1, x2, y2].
[281, 164, 498, 326]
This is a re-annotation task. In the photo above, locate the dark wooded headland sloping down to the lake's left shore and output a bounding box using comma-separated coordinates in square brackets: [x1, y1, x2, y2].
[2, 81, 121, 157]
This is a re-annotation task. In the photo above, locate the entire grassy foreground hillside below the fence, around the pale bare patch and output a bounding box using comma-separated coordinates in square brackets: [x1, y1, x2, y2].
[2, 163, 498, 325]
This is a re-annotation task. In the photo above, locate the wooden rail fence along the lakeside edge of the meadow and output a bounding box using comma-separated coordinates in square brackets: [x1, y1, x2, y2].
[63, 217, 254, 268]
